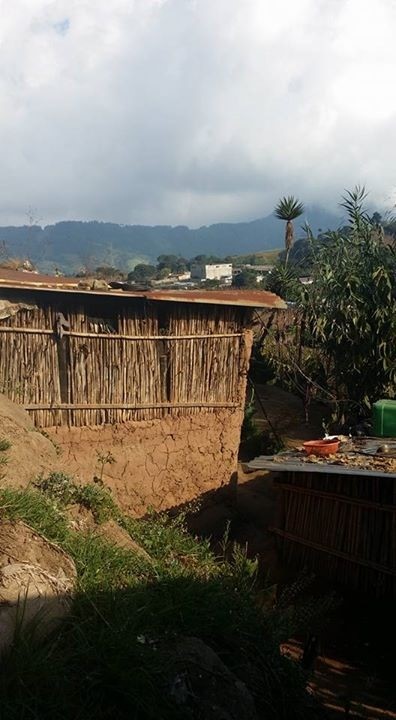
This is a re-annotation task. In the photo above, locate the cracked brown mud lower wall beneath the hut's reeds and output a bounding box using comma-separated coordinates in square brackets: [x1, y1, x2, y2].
[47, 409, 243, 516]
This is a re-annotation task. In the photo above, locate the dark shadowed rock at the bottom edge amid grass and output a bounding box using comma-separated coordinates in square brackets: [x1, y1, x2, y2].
[169, 637, 258, 720]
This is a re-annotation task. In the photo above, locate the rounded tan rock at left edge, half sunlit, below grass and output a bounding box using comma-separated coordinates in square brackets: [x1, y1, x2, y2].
[0, 521, 77, 653]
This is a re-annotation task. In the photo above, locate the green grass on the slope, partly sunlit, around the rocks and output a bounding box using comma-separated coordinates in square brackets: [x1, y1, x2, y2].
[0, 476, 322, 720]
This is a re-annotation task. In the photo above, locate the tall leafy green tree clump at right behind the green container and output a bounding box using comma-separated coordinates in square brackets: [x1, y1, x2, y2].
[262, 187, 396, 431]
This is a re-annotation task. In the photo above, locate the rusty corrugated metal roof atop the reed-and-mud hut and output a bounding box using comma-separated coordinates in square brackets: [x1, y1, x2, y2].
[0, 268, 287, 309]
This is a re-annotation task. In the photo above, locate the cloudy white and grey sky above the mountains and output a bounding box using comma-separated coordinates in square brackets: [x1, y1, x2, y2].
[0, 0, 396, 227]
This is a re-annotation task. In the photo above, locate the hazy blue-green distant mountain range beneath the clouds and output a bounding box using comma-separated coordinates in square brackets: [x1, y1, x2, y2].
[0, 206, 340, 273]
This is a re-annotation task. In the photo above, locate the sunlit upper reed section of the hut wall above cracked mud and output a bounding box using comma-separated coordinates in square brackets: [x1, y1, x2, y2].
[0, 303, 250, 427]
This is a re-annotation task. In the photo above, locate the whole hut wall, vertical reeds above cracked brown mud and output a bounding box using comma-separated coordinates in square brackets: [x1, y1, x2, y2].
[0, 292, 252, 515]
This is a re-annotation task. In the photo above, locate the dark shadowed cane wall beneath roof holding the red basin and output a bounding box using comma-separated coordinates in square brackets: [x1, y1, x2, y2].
[274, 472, 396, 597]
